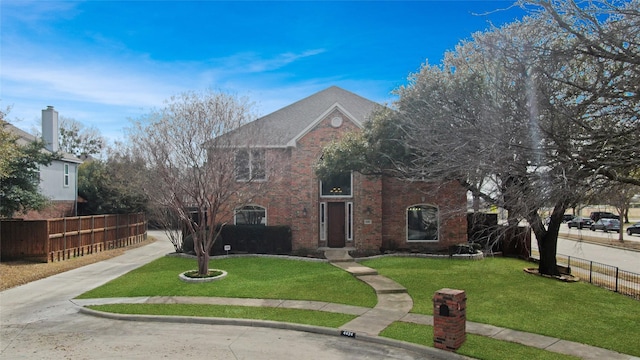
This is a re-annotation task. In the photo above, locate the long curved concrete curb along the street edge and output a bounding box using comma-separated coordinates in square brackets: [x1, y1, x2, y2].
[79, 304, 472, 360]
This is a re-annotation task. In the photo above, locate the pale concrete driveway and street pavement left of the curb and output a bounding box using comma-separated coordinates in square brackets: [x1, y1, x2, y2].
[0, 233, 460, 360]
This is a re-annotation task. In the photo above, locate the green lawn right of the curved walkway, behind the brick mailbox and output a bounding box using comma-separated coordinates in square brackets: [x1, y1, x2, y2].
[363, 257, 640, 356]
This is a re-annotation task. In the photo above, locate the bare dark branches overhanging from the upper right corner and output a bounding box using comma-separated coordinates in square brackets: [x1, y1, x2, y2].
[520, 0, 640, 185]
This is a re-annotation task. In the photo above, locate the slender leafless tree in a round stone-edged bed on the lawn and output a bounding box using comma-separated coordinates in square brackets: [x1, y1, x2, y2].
[130, 91, 258, 275]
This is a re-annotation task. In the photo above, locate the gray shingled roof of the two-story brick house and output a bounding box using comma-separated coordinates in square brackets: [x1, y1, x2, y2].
[228, 86, 381, 147]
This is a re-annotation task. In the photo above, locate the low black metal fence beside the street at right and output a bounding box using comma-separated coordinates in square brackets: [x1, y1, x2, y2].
[556, 254, 640, 300]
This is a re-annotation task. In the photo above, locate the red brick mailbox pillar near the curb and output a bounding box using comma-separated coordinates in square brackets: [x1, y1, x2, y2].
[433, 289, 467, 351]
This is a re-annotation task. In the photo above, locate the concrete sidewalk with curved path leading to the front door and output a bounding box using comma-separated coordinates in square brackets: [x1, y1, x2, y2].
[72, 251, 640, 360]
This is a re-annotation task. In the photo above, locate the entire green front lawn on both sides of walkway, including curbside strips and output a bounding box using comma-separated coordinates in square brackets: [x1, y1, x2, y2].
[79, 257, 640, 359]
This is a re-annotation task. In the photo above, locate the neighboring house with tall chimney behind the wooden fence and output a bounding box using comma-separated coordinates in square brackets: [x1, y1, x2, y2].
[6, 106, 82, 219]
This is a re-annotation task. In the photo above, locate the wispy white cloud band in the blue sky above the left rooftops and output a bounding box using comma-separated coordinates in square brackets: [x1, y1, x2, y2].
[0, 7, 384, 145]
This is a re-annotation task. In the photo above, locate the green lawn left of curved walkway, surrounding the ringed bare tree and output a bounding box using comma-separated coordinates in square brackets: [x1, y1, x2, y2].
[78, 257, 377, 307]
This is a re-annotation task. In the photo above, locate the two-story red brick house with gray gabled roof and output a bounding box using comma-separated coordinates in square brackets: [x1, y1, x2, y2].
[223, 87, 467, 251]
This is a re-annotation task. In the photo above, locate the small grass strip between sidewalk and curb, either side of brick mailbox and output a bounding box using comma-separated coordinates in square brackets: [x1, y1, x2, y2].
[380, 322, 579, 360]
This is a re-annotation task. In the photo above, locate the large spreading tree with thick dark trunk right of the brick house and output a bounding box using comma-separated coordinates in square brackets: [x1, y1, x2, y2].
[321, 1, 640, 275]
